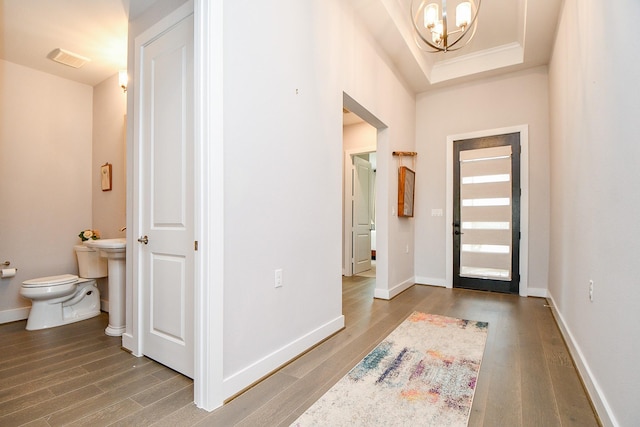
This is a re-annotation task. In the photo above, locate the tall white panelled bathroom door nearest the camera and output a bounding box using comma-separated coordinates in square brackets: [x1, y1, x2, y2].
[137, 10, 195, 377]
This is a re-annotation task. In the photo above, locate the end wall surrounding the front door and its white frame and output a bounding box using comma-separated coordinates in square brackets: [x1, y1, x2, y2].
[415, 67, 549, 292]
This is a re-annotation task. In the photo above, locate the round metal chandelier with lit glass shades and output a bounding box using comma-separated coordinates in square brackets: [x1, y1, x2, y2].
[411, 0, 482, 52]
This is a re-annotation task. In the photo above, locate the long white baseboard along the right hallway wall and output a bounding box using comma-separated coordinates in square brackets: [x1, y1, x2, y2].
[547, 291, 620, 427]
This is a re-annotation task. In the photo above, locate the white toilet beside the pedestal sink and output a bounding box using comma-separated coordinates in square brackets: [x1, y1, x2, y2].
[20, 245, 108, 331]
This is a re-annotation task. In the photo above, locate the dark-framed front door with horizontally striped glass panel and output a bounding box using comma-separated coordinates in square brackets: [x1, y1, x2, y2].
[453, 133, 520, 293]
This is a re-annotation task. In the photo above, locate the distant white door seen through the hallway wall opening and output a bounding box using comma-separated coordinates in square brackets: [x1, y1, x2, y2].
[352, 156, 373, 274]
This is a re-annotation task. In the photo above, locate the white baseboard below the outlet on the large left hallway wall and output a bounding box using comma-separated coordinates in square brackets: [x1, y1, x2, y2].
[223, 315, 344, 399]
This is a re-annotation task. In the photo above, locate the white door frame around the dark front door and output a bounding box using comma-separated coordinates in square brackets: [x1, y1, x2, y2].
[445, 124, 529, 297]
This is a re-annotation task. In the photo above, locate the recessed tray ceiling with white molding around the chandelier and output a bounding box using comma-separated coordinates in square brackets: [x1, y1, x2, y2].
[354, 0, 562, 92]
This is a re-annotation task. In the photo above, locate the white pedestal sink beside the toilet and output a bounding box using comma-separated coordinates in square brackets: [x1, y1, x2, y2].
[84, 238, 127, 337]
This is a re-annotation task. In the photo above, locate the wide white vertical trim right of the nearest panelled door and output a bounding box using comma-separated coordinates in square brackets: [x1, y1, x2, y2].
[193, 0, 228, 411]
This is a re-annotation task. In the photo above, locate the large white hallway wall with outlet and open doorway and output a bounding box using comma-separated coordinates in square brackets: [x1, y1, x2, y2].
[224, 0, 415, 393]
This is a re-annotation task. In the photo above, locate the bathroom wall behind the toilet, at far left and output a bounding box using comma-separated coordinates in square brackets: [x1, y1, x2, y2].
[0, 60, 93, 323]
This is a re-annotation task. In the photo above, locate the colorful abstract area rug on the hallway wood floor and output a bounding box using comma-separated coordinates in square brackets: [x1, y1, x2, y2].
[292, 312, 488, 427]
